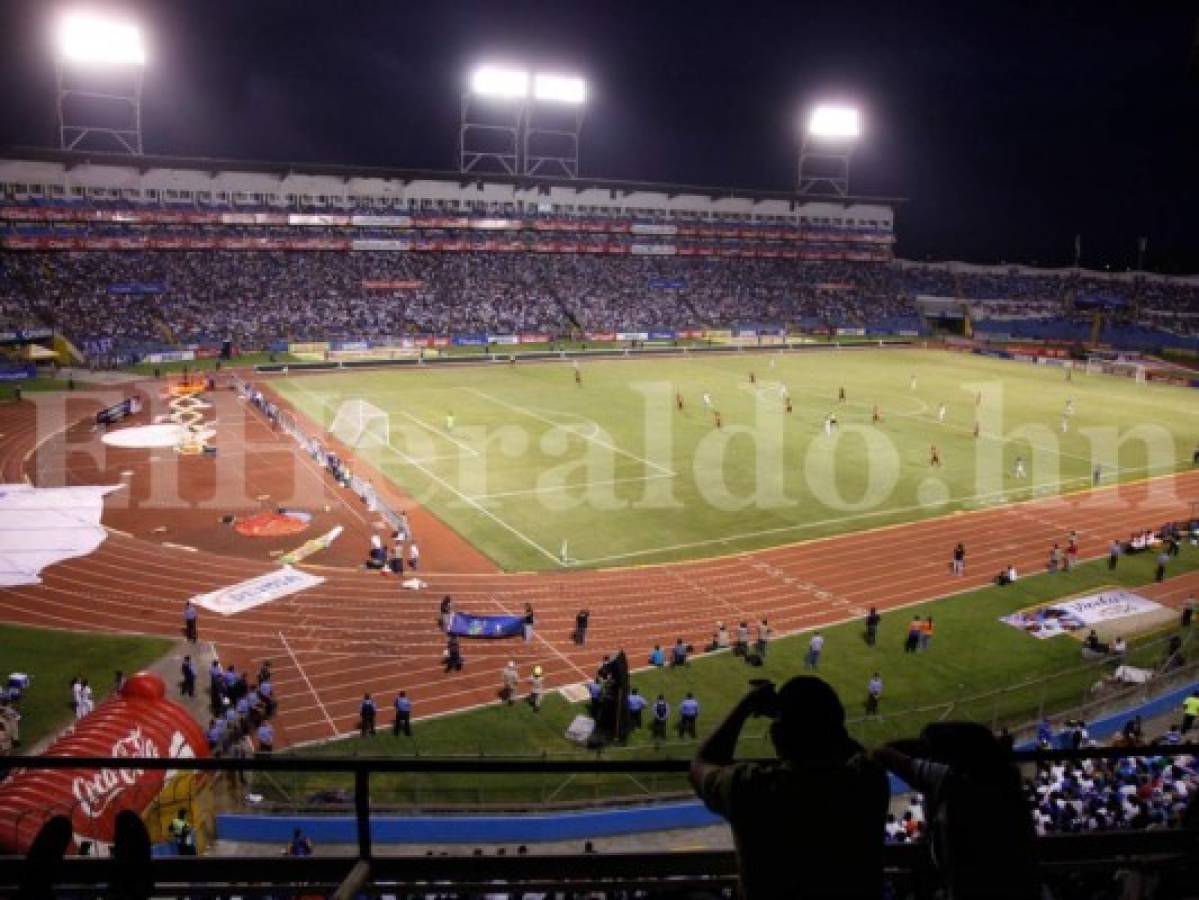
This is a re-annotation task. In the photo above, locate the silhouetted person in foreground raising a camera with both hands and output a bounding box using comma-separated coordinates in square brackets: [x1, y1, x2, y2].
[691, 677, 890, 900]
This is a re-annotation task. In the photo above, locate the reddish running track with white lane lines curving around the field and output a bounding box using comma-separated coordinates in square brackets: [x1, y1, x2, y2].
[0, 397, 1199, 744]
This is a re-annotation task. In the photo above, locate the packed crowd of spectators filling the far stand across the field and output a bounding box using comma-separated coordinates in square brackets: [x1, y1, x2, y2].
[0, 244, 1199, 356]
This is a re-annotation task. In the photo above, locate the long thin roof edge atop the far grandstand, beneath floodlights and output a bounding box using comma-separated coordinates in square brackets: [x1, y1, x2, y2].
[0, 146, 905, 206]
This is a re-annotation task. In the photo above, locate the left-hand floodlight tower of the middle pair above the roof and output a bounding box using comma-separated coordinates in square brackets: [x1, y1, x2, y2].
[458, 66, 529, 175]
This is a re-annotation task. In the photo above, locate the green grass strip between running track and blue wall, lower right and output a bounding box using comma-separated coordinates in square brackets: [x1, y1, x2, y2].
[275, 546, 1199, 805]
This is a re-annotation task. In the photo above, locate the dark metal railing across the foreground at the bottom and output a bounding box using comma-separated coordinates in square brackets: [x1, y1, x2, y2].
[0, 744, 1199, 898]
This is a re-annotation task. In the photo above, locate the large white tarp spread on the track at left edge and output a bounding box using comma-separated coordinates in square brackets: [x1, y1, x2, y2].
[0, 484, 123, 587]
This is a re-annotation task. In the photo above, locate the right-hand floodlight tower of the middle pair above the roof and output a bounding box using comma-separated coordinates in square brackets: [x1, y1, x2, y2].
[524, 73, 588, 179]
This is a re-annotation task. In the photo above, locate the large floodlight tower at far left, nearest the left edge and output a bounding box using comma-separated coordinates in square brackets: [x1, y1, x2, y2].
[55, 13, 146, 156]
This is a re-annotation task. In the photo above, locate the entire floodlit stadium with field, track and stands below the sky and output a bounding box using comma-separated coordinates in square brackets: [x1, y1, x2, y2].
[0, 7, 1199, 898]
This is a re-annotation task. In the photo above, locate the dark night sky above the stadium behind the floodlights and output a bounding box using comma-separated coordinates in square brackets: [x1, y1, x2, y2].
[0, 0, 1199, 272]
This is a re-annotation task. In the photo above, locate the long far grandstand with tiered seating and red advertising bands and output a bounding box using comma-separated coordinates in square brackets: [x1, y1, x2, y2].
[0, 152, 1199, 369]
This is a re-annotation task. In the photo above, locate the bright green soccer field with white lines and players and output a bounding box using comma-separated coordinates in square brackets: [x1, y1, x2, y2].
[272, 350, 1199, 570]
